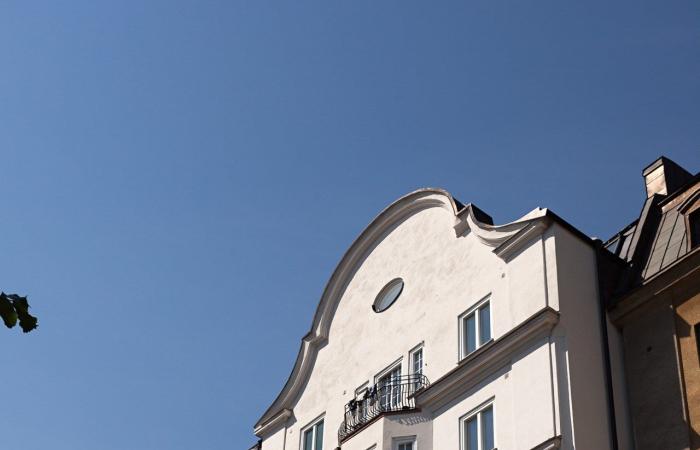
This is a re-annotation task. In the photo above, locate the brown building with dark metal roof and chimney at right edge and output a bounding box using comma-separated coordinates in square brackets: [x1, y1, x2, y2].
[601, 157, 700, 450]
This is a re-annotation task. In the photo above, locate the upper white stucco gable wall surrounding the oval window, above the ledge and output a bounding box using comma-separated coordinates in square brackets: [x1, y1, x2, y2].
[291, 208, 556, 448]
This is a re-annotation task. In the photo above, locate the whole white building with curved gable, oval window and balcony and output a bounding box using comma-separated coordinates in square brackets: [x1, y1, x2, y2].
[255, 189, 626, 450]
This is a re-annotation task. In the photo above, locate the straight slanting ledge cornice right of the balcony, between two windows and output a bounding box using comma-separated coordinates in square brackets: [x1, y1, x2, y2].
[416, 307, 559, 409]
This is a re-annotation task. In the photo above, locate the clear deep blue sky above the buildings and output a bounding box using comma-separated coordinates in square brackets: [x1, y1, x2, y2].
[0, 0, 700, 450]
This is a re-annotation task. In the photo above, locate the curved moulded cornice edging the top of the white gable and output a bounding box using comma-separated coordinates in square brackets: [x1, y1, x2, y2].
[255, 188, 549, 436]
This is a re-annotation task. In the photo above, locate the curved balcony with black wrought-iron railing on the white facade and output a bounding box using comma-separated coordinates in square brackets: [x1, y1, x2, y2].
[338, 374, 430, 443]
